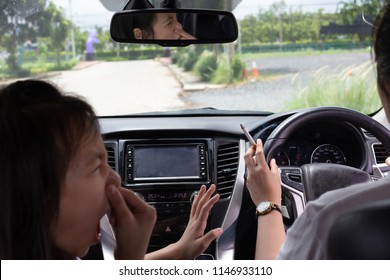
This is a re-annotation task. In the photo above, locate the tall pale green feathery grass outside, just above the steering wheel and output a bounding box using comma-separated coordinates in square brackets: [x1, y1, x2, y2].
[285, 62, 381, 114]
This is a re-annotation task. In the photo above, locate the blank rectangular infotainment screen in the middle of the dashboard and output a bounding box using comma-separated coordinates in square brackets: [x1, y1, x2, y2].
[133, 144, 200, 180]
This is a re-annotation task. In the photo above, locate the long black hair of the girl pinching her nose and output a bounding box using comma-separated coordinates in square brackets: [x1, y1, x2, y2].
[0, 80, 99, 259]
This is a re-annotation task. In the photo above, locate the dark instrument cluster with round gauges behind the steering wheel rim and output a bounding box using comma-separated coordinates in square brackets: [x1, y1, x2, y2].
[259, 121, 369, 168]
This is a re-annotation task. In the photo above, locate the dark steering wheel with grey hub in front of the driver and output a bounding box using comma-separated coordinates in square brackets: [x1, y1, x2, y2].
[264, 107, 390, 215]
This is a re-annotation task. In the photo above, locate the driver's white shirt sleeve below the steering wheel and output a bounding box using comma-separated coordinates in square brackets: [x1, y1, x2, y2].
[277, 176, 390, 260]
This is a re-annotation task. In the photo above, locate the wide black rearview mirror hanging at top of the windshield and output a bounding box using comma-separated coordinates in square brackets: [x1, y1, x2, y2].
[110, 9, 238, 46]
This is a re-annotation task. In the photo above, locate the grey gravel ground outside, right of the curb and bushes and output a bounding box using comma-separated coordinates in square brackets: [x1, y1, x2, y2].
[183, 51, 371, 112]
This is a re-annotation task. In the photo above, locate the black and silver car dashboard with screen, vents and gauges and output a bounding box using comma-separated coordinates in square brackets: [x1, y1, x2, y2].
[99, 112, 387, 259]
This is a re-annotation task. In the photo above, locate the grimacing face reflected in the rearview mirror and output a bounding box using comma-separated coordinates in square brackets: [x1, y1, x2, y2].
[133, 13, 196, 40]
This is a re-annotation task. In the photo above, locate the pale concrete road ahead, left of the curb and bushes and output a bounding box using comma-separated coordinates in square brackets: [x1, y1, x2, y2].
[49, 60, 184, 116]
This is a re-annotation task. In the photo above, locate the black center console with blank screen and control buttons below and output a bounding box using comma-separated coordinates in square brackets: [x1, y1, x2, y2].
[119, 139, 213, 251]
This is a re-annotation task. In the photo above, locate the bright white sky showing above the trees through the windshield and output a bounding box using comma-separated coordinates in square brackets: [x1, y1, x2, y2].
[52, 0, 340, 29]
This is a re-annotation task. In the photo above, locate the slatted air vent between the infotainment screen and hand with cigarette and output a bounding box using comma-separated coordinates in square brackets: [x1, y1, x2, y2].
[217, 143, 239, 198]
